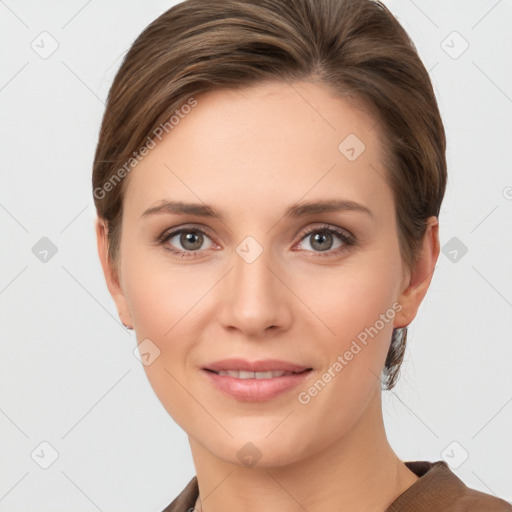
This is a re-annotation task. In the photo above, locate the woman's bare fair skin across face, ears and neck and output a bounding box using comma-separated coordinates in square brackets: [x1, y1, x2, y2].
[96, 82, 439, 512]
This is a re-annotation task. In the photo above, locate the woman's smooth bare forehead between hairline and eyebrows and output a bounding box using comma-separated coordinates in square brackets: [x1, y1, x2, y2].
[125, 82, 392, 222]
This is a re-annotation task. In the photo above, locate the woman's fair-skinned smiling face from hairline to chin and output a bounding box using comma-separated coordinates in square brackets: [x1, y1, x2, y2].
[99, 83, 432, 466]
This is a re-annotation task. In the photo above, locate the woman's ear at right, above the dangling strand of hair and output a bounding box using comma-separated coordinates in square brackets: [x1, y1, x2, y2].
[393, 217, 439, 328]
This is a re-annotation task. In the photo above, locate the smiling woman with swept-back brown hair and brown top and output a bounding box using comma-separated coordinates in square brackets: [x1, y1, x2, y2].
[93, 0, 512, 512]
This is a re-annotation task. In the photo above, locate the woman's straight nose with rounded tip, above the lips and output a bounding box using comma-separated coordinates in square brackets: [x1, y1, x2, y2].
[219, 240, 293, 339]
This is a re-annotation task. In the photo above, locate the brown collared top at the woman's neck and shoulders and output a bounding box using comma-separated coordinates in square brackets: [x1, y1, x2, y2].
[162, 460, 512, 512]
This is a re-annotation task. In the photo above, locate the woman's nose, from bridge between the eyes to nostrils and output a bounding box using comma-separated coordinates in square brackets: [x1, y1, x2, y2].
[222, 237, 287, 336]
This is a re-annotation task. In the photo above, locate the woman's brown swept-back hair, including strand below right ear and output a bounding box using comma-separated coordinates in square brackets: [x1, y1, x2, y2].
[92, 0, 446, 389]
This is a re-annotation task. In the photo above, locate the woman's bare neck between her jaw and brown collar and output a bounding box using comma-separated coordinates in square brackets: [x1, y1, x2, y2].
[189, 388, 418, 512]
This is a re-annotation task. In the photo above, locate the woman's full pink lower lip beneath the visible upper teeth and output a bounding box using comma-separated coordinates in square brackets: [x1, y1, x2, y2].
[202, 370, 312, 402]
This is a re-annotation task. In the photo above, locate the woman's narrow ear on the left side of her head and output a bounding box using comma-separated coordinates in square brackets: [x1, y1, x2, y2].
[96, 217, 133, 329]
